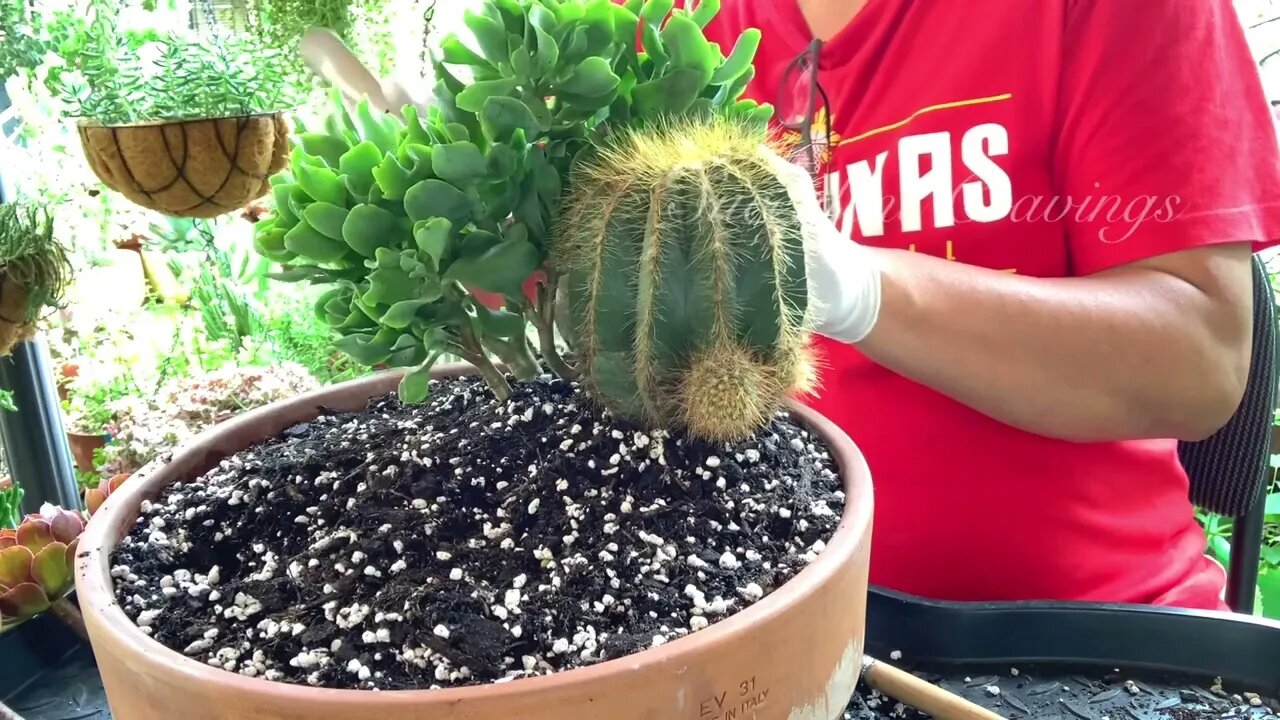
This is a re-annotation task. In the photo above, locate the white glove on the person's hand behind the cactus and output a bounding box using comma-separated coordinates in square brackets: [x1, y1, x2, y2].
[764, 149, 881, 345]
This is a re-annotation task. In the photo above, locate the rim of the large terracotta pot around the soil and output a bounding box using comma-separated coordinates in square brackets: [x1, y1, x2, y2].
[67, 365, 873, 707]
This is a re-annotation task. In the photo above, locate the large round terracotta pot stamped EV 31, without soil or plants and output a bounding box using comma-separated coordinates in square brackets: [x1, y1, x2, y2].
[76, 368, 872, 720]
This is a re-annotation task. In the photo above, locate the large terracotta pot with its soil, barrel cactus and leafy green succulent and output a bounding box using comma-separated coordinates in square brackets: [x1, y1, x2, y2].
[77, 0, 870, 720]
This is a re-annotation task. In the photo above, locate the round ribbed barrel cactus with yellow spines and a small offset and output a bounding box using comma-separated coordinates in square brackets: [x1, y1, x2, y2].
[553, 117, 813, 439]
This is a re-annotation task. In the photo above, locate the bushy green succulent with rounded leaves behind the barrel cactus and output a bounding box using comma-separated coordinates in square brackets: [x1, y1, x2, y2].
[256, 0, 772, 420]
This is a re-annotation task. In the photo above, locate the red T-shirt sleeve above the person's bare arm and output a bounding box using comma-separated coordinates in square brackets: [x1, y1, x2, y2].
[1053, 0, 1280, 274]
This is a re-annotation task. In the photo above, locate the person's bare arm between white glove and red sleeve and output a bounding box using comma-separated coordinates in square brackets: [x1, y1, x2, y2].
[858, 250, 1249, 441]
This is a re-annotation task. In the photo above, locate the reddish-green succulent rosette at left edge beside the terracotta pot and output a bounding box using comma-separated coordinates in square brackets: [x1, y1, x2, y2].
[0, 503, 84, 629]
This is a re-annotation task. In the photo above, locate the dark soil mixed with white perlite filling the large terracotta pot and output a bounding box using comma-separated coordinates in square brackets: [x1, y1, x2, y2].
[111, 368, 844, 689]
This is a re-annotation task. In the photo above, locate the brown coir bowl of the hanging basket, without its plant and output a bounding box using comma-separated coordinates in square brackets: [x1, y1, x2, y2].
[79, 113, 289, 218]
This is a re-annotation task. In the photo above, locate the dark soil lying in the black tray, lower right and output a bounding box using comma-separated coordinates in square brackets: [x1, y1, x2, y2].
[845, 664, 1280, 720]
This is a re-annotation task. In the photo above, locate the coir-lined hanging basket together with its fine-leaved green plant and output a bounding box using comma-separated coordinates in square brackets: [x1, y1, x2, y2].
[68, 0, 298, 218]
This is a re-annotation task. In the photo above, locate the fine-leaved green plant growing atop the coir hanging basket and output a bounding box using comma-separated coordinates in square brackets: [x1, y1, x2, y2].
[64, 0, 296, 126]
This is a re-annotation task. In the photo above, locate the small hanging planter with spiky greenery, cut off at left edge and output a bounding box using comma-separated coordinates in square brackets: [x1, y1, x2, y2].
[0, 201, 72, 356]
